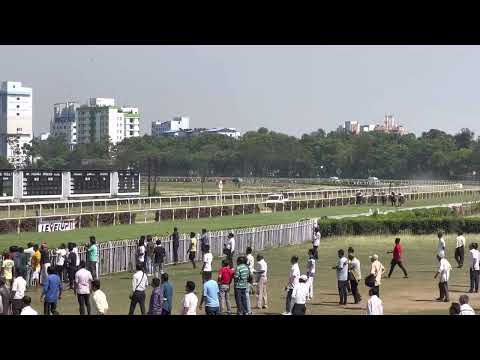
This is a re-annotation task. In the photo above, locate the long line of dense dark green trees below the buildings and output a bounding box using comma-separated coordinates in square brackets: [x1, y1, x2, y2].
[6, 128, 480, 179]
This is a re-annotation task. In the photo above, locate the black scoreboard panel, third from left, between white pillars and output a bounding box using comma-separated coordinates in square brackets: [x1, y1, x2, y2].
[70, 170, 110, 195]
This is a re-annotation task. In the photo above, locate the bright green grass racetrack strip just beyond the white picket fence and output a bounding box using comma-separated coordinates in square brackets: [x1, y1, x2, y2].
[0, 193, 478, 249]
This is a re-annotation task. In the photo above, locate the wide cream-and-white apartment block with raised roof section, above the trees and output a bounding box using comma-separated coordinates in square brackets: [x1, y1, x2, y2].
[76, 98, 140, 144]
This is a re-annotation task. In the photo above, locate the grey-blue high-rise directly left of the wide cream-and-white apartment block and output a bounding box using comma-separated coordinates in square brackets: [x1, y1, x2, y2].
[50, 101, 80, 149]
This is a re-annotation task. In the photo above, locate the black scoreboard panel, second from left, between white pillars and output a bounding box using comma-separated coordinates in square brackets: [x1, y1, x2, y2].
[23, 171, 62, 197]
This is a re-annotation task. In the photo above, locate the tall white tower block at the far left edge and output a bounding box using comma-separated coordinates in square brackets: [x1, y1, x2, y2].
[0, 81, 33, 166]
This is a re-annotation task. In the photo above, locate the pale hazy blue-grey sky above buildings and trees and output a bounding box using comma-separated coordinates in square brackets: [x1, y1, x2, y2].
[0, 46, 480, 136]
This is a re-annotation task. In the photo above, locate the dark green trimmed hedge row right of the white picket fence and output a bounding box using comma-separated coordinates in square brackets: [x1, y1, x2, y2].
[320, 216, 480, 236]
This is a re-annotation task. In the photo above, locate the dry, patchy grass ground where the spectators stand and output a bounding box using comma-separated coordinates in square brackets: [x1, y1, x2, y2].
[24, 234, 480, 315]
